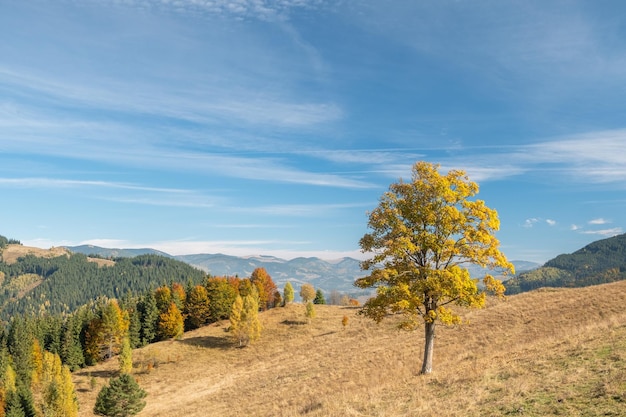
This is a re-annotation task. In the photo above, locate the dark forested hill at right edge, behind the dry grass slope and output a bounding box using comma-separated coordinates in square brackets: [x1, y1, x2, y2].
[506, 234, 626, 294]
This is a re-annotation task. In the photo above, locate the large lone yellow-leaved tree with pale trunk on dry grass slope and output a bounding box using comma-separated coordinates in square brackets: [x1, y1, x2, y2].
[355, 162, 514, 374]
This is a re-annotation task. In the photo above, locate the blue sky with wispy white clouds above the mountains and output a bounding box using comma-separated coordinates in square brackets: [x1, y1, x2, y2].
[0, 0, 626, 262]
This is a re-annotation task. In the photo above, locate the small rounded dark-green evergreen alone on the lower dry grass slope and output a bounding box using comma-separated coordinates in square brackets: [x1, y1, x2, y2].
[94, 374, 146, 417]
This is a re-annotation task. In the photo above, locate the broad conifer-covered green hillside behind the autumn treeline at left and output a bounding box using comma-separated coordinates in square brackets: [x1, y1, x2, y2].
[0, 238, 206, 320]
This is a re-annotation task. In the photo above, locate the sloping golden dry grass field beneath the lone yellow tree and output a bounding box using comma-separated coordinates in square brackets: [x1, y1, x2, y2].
[74, 282, 626, 417]
